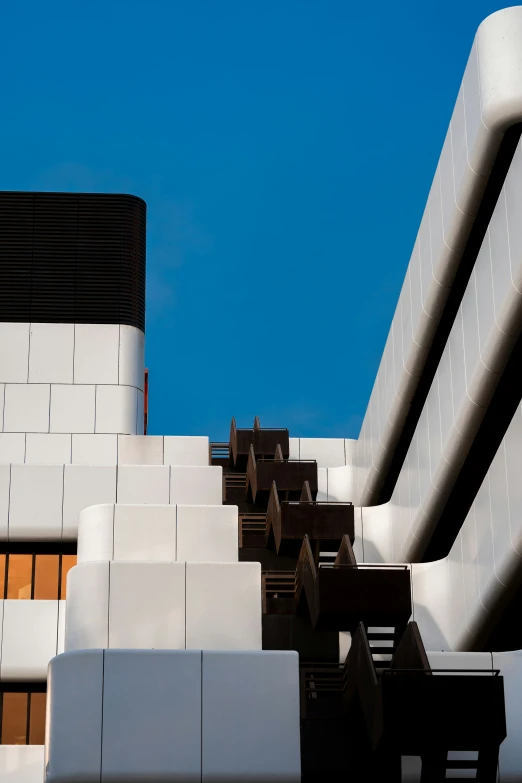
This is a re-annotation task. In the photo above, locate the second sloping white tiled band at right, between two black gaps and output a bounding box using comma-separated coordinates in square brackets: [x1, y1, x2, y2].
[391, 132, 522, 561]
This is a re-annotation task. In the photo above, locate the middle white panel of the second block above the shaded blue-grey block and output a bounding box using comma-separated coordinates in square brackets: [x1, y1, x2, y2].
[114, 505, 177, 563]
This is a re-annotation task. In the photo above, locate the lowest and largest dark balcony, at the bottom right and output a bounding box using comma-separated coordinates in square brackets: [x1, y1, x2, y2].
[300, 622, 506, 783]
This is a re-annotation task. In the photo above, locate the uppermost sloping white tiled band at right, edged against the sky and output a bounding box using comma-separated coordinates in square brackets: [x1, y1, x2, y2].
[354, 7, 522, 506]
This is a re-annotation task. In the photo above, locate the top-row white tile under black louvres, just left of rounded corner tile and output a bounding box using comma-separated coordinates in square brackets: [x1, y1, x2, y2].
[74, 324, 120, 384]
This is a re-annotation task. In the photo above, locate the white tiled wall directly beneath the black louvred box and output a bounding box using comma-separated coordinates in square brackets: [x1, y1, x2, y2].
[0, 322, 144, 438]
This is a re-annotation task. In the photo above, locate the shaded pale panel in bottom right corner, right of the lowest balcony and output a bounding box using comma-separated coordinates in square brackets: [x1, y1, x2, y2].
[493, 650, 522, 783]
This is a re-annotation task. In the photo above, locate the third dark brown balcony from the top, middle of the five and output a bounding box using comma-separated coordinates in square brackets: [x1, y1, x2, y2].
[266, 481, 355, 557]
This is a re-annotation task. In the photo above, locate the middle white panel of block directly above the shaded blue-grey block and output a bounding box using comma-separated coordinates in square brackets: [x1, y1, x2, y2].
[109, 562, 185, 650]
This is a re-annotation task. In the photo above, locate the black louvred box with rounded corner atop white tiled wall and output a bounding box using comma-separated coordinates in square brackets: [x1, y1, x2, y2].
[0, 192, 146, 330]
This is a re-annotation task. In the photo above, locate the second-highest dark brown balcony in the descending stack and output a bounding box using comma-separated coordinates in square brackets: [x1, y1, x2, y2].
[247, 444, 317, 508]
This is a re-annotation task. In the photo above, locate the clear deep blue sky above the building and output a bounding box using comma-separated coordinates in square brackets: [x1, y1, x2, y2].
[0, 0, 508, 440]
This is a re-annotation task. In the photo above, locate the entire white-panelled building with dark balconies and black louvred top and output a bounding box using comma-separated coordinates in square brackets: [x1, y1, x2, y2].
[0, 7, 522, 783]
